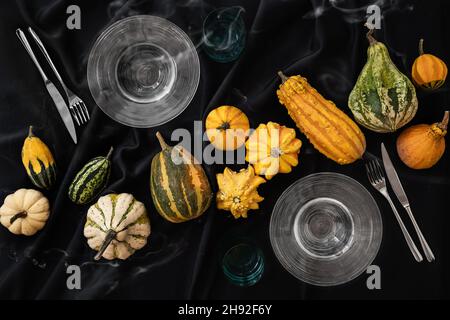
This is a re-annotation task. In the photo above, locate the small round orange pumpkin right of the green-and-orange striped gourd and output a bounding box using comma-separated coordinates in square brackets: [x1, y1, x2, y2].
[205, 106, 250, 150]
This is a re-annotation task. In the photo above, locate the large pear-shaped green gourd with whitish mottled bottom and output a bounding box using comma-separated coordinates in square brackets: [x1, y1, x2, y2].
[348, 30, 418, 132]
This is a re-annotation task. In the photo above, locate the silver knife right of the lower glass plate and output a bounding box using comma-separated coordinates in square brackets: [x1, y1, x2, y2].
[381, 143, 434, 262]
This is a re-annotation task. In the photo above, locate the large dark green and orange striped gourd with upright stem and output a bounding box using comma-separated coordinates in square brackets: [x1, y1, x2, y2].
[150, 132, 213, 223]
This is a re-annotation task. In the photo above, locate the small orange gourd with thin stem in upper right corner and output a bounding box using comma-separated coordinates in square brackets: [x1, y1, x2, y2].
[411, 39, 448, 89]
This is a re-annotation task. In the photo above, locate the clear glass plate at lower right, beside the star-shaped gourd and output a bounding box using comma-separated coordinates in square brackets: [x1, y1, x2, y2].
[270, 172, 383, 286]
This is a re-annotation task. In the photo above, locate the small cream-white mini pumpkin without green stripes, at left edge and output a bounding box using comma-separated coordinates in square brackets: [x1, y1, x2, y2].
[0, 189, 50, 236]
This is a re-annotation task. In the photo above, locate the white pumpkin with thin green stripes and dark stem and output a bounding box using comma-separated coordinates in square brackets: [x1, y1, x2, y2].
[84, 193, 150, 260]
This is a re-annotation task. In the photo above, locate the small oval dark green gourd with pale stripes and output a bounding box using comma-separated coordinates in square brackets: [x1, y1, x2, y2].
[69, 148, 113, 204]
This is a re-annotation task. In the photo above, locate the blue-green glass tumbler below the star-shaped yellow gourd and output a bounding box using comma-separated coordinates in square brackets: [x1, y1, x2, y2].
[222, 242, 264, 287]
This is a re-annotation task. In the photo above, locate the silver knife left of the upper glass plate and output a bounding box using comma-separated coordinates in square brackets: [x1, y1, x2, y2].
[16, 28, 77, 144]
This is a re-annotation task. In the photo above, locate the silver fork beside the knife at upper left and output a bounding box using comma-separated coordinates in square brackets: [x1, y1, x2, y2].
[28, 27, 90, 126]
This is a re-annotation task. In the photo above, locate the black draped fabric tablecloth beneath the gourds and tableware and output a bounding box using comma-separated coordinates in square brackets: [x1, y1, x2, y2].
[0, 0, 450, 299]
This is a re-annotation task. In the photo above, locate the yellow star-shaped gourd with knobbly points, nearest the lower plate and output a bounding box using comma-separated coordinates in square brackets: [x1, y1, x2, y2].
[216, 165, 266, 219]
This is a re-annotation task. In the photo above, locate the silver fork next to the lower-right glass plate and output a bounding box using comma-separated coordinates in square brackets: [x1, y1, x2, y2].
[366, 159, 423, 262]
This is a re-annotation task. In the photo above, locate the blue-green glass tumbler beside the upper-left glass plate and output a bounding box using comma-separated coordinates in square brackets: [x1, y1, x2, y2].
[203, 7, 247, 63]
